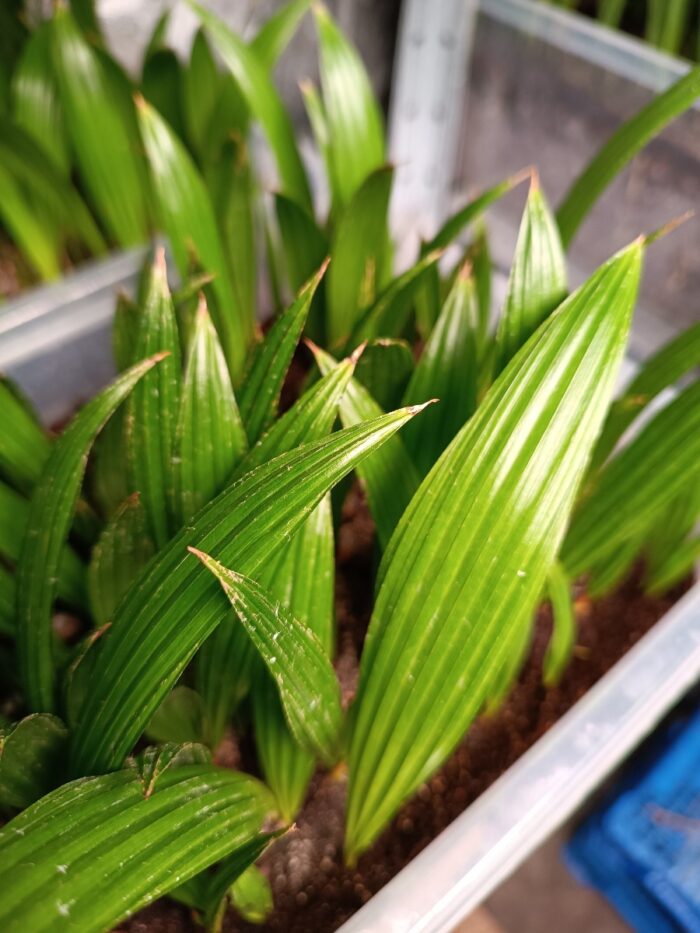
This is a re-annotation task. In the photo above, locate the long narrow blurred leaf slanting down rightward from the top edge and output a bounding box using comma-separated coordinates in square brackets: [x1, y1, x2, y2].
[189, 0, 311, 209]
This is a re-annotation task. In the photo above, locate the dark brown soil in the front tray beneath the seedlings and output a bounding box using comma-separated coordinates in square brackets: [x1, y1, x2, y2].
[118, 487, 685, 933]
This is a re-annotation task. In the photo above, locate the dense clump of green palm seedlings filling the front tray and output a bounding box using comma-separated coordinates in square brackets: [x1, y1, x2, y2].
[0, 1, 700, 931]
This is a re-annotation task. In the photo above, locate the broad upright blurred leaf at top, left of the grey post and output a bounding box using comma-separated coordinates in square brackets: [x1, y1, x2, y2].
[313, 3, 386, 207]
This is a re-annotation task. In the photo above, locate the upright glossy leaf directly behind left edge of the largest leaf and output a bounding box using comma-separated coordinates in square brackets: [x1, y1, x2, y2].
[403, 266, 478, 476]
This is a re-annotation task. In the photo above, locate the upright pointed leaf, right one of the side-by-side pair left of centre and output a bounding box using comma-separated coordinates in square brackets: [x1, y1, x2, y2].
[175, 298, 248, 524]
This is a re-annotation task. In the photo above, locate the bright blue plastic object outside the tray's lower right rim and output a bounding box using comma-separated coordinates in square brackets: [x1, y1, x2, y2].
[566, 712, 700, 933]
